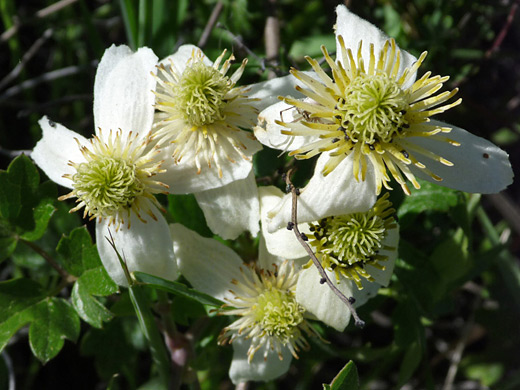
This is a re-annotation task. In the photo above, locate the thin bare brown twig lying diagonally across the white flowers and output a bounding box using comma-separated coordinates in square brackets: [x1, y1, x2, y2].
[285, 171, 365, 328]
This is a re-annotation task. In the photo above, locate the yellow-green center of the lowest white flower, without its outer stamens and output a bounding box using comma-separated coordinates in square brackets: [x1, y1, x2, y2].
[254, 288, 305, 340]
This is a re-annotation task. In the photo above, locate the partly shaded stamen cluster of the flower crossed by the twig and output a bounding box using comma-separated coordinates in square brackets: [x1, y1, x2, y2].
[306, 192, 396, 289]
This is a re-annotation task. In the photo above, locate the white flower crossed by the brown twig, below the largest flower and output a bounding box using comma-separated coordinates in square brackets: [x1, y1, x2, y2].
[259, 186, 399, 331]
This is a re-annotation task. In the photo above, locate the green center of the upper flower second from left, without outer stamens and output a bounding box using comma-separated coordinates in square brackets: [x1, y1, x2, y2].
[174, 62, 232, 126]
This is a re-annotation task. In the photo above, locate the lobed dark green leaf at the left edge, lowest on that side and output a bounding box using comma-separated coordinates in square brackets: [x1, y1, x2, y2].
[0, 279, 80, 363]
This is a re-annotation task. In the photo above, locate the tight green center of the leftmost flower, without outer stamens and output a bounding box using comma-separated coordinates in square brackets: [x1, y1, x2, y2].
[72, 157, 145, 217]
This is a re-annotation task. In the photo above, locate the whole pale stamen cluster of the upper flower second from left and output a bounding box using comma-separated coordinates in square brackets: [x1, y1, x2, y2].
[153, 50, 258, 177]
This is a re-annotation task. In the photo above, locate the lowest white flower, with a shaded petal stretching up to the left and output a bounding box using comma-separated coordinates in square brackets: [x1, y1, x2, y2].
[170, 224, 315, 384]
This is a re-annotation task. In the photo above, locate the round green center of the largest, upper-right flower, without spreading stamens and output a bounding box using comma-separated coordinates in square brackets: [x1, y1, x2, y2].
[334, 73, 409, 145]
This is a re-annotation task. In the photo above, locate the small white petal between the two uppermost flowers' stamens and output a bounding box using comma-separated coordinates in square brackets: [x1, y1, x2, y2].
[247, 72, 304, 111]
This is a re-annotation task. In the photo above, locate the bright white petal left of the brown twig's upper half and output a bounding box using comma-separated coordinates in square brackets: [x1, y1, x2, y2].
[258, 186, 310, 259]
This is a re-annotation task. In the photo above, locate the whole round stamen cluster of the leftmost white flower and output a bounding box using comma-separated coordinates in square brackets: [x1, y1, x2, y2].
[59, 130, 168, 230]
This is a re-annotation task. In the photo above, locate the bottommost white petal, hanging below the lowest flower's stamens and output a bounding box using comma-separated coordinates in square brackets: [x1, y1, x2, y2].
[229, 338, 292, 385]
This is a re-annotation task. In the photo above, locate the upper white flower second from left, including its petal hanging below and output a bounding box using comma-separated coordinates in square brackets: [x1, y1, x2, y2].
[153, 45, 300, 239]
